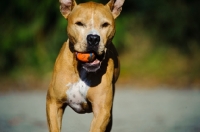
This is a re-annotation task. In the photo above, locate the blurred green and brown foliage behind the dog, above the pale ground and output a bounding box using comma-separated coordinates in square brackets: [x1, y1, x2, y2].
[0, 0, 200, 90]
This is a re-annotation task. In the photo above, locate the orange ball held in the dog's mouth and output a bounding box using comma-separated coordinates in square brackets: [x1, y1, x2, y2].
[76, 53, 95, 62]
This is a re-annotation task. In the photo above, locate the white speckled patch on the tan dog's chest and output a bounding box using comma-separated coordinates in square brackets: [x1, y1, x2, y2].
[66, 80, 89, 112]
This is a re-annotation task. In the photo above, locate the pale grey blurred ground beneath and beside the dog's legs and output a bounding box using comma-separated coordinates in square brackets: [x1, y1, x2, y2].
[0, 88, 200, 132]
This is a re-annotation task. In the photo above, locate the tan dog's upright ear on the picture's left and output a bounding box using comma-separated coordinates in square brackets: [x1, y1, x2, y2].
[59, 0, 77, 19]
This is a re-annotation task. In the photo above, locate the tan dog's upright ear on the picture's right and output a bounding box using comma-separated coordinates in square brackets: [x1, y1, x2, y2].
[106, 0, 125, 18]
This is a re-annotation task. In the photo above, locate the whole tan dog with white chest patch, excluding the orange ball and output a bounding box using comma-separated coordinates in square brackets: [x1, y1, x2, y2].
[46, 0, 124, 132]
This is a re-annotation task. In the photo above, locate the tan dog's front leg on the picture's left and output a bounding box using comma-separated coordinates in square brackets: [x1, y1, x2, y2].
[46, 96, 66, 132]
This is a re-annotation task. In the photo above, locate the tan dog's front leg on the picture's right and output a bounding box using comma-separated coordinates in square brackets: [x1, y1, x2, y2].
[90, 85, 113, 132]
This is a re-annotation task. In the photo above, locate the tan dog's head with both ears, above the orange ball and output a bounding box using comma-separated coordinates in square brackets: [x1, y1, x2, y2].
[59, 0, 124, 71]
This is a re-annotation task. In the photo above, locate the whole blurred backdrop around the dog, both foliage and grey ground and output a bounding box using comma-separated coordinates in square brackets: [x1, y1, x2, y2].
[0, 0, 200, 132]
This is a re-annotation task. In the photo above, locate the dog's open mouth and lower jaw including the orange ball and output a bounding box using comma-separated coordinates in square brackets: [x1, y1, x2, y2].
[76, 52, 101, 72]
